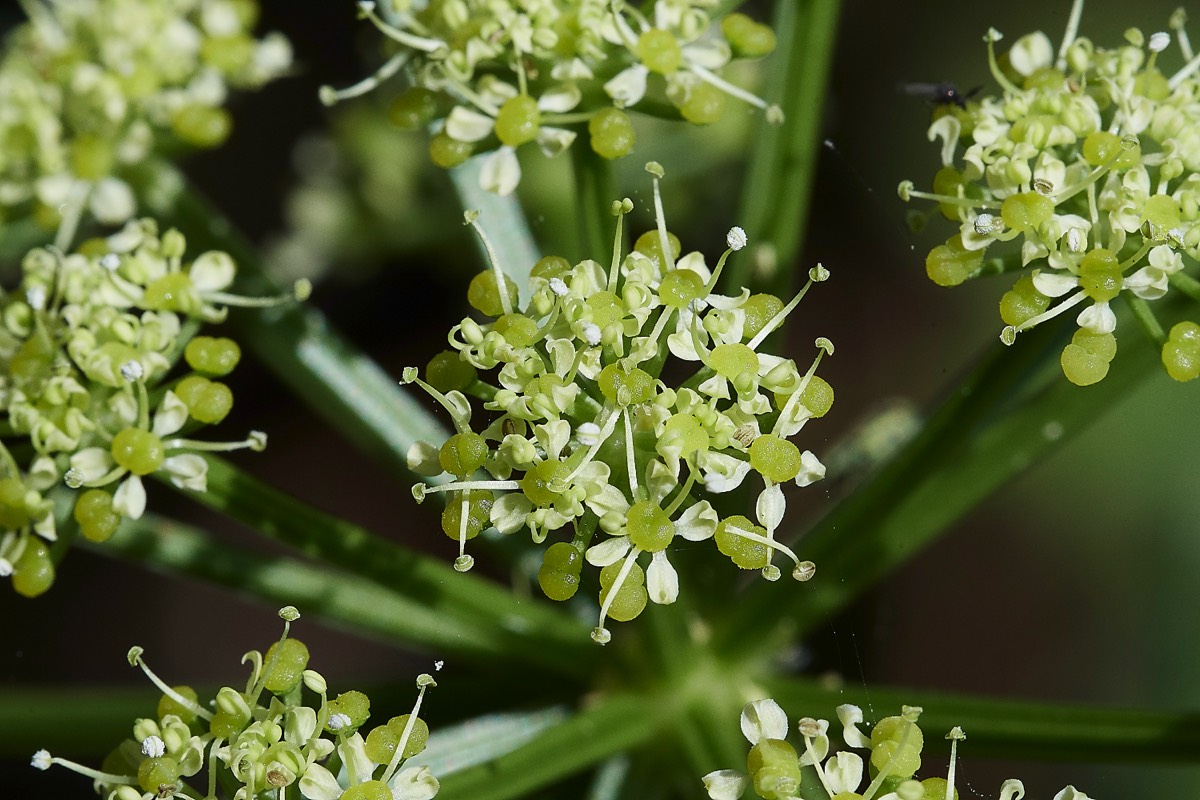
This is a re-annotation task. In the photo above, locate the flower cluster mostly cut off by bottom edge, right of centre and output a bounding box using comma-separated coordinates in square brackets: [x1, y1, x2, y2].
[703, 699, 1088, 800]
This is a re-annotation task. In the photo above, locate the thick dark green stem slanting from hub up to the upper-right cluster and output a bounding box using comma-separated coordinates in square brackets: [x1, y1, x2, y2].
[718, 311, 1158, 658]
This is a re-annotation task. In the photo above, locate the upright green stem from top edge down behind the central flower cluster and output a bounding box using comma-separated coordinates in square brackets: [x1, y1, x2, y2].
[725, 0, 840, 295]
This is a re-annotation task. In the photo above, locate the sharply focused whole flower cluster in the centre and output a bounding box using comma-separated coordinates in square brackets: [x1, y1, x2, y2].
[404, 163, 833, 643]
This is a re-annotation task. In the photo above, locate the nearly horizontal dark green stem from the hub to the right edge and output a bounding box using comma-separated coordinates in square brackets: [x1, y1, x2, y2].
[766, 679, 1200, 769]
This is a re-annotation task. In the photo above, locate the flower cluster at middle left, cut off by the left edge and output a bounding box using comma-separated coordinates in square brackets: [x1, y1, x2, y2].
[0, 219, 307, 596]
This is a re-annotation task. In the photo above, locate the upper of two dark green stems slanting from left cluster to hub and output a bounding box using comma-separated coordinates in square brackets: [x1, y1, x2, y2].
[175, 457, 594, 676]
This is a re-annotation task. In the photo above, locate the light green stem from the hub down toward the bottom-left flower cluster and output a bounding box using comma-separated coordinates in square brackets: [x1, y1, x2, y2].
[438, 694, 662, 800]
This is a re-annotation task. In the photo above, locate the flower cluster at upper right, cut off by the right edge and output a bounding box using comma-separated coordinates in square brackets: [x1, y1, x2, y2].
[900, 0, 1200, 385]
